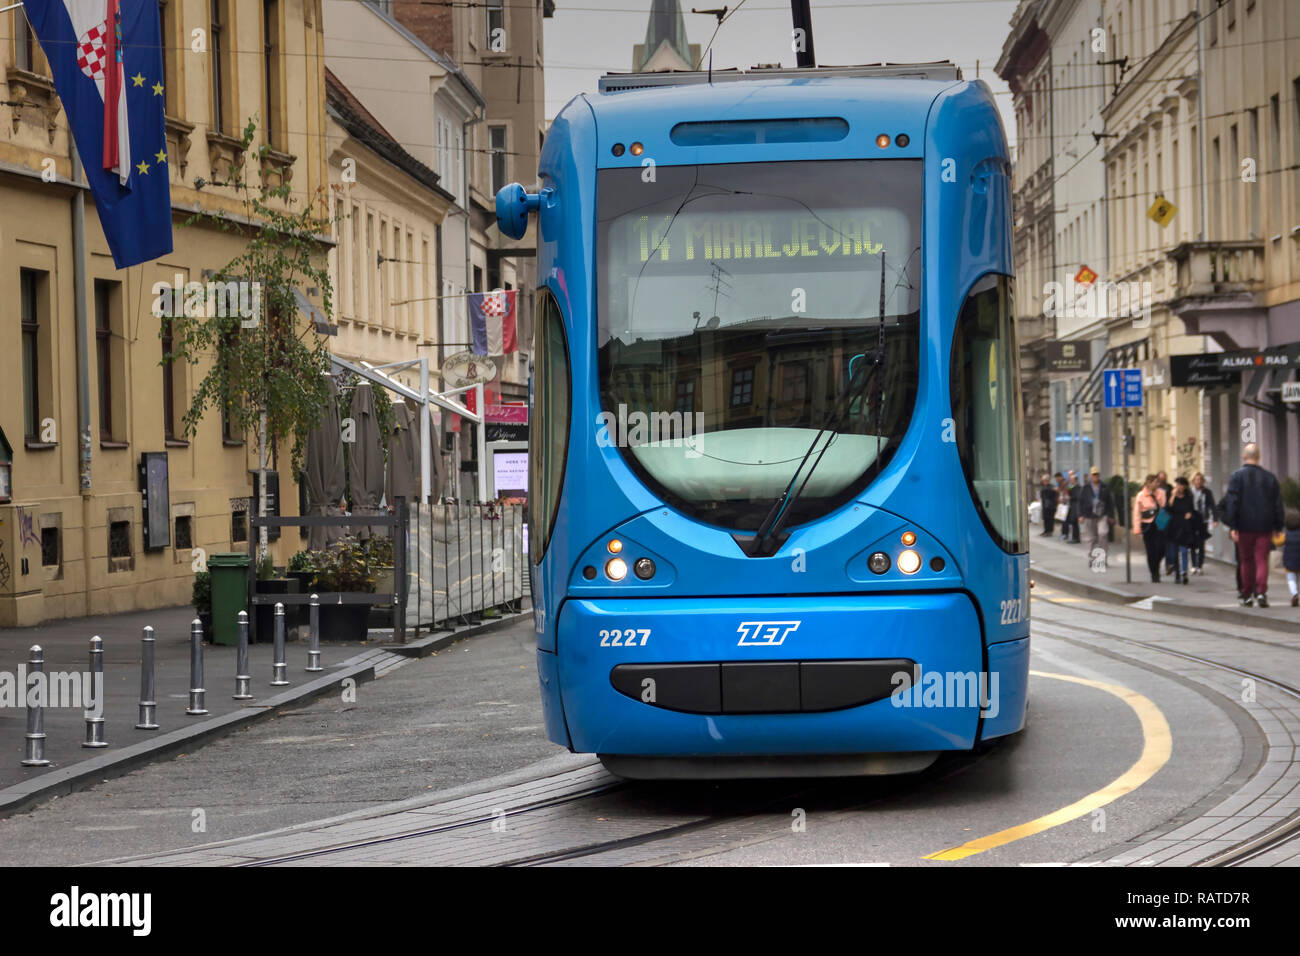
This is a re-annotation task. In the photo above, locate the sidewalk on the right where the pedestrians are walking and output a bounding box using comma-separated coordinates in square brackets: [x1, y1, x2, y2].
[1030, 524, 1300, 635]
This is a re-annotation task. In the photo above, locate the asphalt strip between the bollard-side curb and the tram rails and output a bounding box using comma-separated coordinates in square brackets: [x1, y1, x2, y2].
[0, 629, 563, 866]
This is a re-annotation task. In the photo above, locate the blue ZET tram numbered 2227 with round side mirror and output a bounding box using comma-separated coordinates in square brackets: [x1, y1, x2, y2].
[497, 64, 1030, 778]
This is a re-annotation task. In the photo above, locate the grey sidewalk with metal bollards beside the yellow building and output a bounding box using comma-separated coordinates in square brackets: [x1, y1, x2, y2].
[0, 607, 382, 788]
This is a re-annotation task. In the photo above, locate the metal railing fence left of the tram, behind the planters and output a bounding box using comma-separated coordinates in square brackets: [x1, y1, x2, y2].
[406, 503, 528, 633]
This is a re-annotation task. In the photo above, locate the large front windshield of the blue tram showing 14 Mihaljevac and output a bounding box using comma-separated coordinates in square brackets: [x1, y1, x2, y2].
[595, 160, 922, 531]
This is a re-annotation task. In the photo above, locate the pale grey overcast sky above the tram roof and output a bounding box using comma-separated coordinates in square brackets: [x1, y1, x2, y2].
[543, 0, 1015, 143]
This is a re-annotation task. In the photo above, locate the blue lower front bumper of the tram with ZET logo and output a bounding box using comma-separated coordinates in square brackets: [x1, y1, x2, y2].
[547, 592, 1003, 756]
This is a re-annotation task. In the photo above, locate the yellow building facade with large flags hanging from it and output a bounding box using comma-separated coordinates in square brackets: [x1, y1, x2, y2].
[0, 0, 328, 626]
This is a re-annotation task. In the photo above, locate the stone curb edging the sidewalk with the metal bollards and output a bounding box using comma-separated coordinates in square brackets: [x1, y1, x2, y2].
[0, 611, 532, 819]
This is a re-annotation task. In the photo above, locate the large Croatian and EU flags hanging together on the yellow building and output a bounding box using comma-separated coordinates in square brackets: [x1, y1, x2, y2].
[23, 0, 172, 269]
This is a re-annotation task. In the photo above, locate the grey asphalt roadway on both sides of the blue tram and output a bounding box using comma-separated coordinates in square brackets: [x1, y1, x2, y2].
[0, 598, 1300, 866]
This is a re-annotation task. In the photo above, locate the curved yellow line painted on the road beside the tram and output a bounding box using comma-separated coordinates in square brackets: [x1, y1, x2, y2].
[923, 671, 1173, 860]
